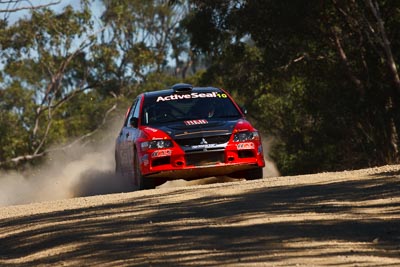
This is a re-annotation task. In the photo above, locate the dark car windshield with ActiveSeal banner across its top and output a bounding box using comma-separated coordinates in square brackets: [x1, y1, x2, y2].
[142, 92, 242, 125]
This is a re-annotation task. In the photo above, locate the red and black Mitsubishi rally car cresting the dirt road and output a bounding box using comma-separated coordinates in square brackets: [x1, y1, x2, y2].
[115, 84, 265, 189]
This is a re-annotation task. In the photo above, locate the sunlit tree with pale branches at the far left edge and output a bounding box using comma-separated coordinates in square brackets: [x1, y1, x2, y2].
[0, 2, 107, 168]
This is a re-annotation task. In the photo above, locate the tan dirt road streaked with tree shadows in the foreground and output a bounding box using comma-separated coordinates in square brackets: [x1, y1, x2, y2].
[0, 165, 400, 266]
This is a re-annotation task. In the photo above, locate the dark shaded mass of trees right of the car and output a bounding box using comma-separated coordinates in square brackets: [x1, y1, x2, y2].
[186, 0, 400, 174]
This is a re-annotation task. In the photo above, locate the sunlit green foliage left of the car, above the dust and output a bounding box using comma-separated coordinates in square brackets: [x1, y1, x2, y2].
[0, 0, 194, 167]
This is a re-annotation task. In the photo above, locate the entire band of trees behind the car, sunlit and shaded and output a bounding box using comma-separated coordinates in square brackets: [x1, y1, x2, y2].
[0, 0, 400, 174]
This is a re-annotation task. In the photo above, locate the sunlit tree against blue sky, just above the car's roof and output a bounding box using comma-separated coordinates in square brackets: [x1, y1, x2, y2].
[102, 0, 190, 87]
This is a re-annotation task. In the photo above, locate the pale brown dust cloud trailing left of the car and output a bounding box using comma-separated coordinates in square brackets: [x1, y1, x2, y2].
[0, 120, 132, 207]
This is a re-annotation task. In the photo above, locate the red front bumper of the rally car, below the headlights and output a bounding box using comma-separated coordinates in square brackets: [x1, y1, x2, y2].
[141, 142, 265, 180]
